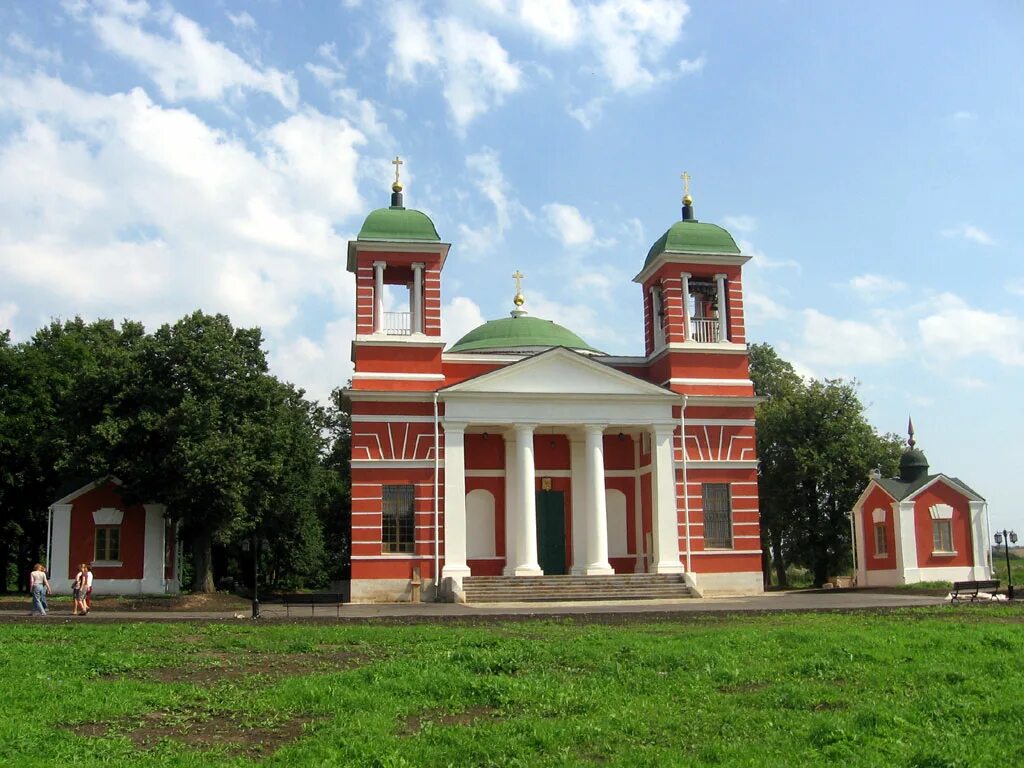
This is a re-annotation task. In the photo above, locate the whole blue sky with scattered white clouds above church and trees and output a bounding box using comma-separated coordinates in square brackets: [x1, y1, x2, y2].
[0, 0, 1024, 527]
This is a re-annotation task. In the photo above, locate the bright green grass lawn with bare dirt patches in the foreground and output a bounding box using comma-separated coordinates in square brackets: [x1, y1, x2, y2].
[0, 605, 1024, 768]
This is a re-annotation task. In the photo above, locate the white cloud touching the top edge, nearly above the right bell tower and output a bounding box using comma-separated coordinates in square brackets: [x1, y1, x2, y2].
[587, 0, 689, 90]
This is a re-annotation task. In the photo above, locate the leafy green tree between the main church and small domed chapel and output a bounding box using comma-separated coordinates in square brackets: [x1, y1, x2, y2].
[752, 345, 900, 586]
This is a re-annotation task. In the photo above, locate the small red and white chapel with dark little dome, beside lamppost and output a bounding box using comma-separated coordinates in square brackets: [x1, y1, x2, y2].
[853, 423, 992, 587]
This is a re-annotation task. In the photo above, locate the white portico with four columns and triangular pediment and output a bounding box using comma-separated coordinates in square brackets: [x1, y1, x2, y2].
[439, 348, 683, 592]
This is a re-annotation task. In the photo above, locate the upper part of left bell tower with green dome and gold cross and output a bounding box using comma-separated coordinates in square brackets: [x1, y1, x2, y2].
[348, 157, 451, 390]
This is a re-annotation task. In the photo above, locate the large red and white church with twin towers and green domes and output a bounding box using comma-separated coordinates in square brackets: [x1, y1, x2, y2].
[348, 163, 762, 602]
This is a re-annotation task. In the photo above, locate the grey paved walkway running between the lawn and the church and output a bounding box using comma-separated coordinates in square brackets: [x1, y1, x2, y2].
[0, 590, 945, 624]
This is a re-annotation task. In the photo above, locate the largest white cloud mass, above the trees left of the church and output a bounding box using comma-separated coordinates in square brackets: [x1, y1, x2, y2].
[0, 75, 365, 397]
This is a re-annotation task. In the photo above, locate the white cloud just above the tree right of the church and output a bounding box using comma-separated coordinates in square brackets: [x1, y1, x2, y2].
[799, 309, 906, 368]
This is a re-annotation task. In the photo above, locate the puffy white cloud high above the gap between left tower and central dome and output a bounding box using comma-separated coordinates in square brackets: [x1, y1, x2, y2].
[387, 3, 521, 131]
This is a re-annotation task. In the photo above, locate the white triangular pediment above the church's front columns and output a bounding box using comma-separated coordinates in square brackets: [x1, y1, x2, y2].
[440, 348, 679, 401]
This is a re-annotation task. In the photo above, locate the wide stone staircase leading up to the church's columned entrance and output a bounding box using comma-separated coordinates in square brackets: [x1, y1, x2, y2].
[463, 573, 693, 603]
